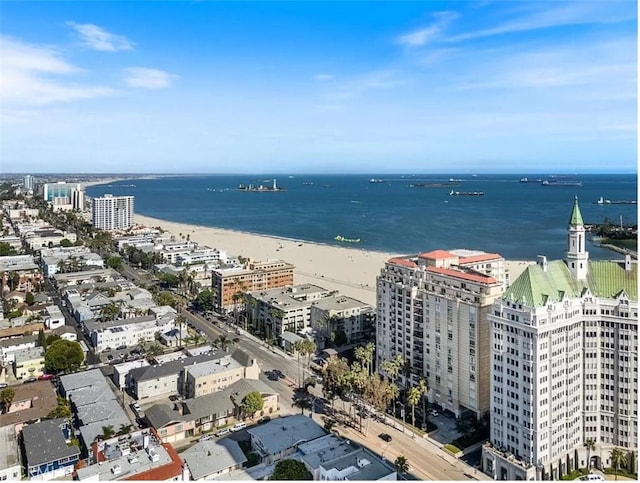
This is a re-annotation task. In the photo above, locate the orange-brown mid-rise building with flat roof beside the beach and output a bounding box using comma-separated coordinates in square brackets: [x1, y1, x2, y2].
[211, 259, 295, 312]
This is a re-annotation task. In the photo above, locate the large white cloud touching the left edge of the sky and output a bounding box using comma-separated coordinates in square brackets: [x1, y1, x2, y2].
[0, 37, 117, 106]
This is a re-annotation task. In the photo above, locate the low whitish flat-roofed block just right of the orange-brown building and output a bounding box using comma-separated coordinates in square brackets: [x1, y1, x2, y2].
[246, 283, 332, 340]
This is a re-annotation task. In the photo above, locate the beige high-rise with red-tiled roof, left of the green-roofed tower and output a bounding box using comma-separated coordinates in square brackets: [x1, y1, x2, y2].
[376, 250, 507, 418]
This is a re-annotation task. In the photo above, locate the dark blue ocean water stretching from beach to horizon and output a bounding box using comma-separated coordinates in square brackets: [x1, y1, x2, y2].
[87, 174, 638, 259]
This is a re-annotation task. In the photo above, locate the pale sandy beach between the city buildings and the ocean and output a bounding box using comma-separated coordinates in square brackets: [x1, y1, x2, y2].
[134, 214, 533, 306]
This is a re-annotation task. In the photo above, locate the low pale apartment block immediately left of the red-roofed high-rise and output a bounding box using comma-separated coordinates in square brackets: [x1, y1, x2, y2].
[309, 295, 375, 349]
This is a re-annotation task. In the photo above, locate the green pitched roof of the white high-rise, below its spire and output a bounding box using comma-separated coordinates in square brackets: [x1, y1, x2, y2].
[503, 260, 638, 307]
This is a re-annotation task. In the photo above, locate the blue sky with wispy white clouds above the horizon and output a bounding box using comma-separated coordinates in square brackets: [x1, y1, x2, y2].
[0, 0, 637, 173]
